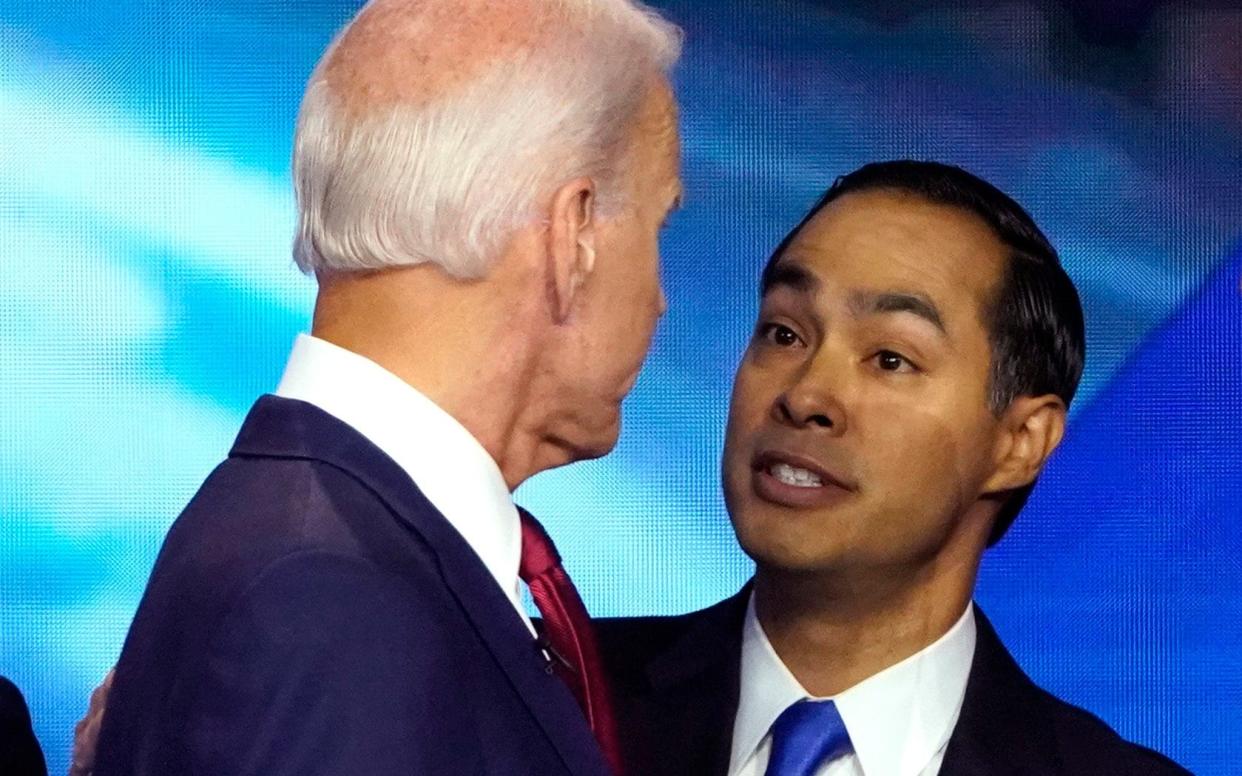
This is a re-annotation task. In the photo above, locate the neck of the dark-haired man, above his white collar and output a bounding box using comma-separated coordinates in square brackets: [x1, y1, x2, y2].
[755, 561, 977, 697]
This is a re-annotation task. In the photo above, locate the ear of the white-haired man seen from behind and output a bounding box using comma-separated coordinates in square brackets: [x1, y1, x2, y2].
[548, 178, 595, 323]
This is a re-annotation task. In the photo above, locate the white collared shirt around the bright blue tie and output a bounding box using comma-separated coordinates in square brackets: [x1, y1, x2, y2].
[729, 596, 975, 776]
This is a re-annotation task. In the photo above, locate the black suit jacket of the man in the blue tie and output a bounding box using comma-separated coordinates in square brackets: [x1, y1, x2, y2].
[597, 586, 1186, 776]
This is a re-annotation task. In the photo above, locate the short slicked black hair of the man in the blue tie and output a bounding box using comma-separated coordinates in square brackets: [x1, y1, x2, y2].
[763, 160, 1087, 546]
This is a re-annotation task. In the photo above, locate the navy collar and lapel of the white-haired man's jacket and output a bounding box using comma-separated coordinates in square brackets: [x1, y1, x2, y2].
[233, 396, 607, 774]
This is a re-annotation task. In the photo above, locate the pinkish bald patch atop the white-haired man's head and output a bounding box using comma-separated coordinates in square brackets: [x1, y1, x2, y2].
[319, 0, 568, 112]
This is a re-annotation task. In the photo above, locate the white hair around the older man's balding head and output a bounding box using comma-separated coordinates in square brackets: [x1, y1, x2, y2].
[293, 0, 681, 278]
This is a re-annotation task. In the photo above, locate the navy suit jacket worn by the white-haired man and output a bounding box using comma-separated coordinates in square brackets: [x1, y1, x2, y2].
[94, 396, 606, 776]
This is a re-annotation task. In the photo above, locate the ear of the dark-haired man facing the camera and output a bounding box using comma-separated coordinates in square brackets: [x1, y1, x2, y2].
[984, 394, 1066, 493]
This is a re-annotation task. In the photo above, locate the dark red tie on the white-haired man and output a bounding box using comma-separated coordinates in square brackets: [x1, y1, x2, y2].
[518, 507, 622, 774]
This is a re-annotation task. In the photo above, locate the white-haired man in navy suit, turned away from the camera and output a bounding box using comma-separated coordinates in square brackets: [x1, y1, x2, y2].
[87, 0, 681, 776]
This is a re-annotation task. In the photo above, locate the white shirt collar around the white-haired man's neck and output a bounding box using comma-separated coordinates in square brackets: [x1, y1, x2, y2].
[276, 334, 534, 633]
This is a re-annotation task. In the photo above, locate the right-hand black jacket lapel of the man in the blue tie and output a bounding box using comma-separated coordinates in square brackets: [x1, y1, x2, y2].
[940, 605, 1061, 776]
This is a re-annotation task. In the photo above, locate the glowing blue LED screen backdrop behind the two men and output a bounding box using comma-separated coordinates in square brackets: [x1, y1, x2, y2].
[0, 0, 1242, 774]
